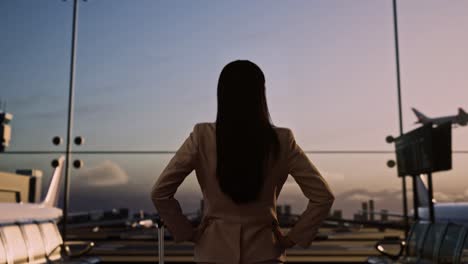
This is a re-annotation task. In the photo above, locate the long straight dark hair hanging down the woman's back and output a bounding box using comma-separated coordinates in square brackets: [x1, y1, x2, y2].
[216, 60, 279, 204]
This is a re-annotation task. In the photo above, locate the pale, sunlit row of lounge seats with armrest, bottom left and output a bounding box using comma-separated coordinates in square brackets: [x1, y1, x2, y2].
[0, 221, 99, 264]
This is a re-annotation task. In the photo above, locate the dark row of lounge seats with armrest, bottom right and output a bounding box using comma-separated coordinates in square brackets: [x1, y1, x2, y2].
[368, 223, 468, 264]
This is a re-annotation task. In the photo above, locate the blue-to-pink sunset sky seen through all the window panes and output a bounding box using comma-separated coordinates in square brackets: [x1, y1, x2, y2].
[0, 0, 468, 218]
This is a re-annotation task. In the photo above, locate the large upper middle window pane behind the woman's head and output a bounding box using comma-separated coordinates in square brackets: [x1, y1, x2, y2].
[74, 0, 398, 150]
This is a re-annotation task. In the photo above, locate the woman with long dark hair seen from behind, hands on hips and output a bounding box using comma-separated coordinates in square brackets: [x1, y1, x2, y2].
[151, 60, 334, 263]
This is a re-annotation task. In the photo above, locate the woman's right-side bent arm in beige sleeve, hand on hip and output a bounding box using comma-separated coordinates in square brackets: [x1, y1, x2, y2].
[287, 129, 335, 248]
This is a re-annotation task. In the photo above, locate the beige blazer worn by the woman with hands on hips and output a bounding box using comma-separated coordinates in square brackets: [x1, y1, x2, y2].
[151, 123, 334, 263]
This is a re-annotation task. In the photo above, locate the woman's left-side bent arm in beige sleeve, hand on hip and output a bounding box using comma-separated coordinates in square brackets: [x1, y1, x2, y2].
[151, 125, 198, 242]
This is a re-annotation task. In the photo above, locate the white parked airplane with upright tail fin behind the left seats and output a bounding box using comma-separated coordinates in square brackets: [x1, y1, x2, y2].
[0, 156, 65, 225]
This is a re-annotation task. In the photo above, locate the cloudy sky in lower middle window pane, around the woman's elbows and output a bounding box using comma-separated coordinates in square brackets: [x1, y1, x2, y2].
[66, 154, 401, 219]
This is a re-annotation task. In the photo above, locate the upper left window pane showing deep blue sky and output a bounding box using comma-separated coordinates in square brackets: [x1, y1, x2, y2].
[0, 0, 72, 151]
